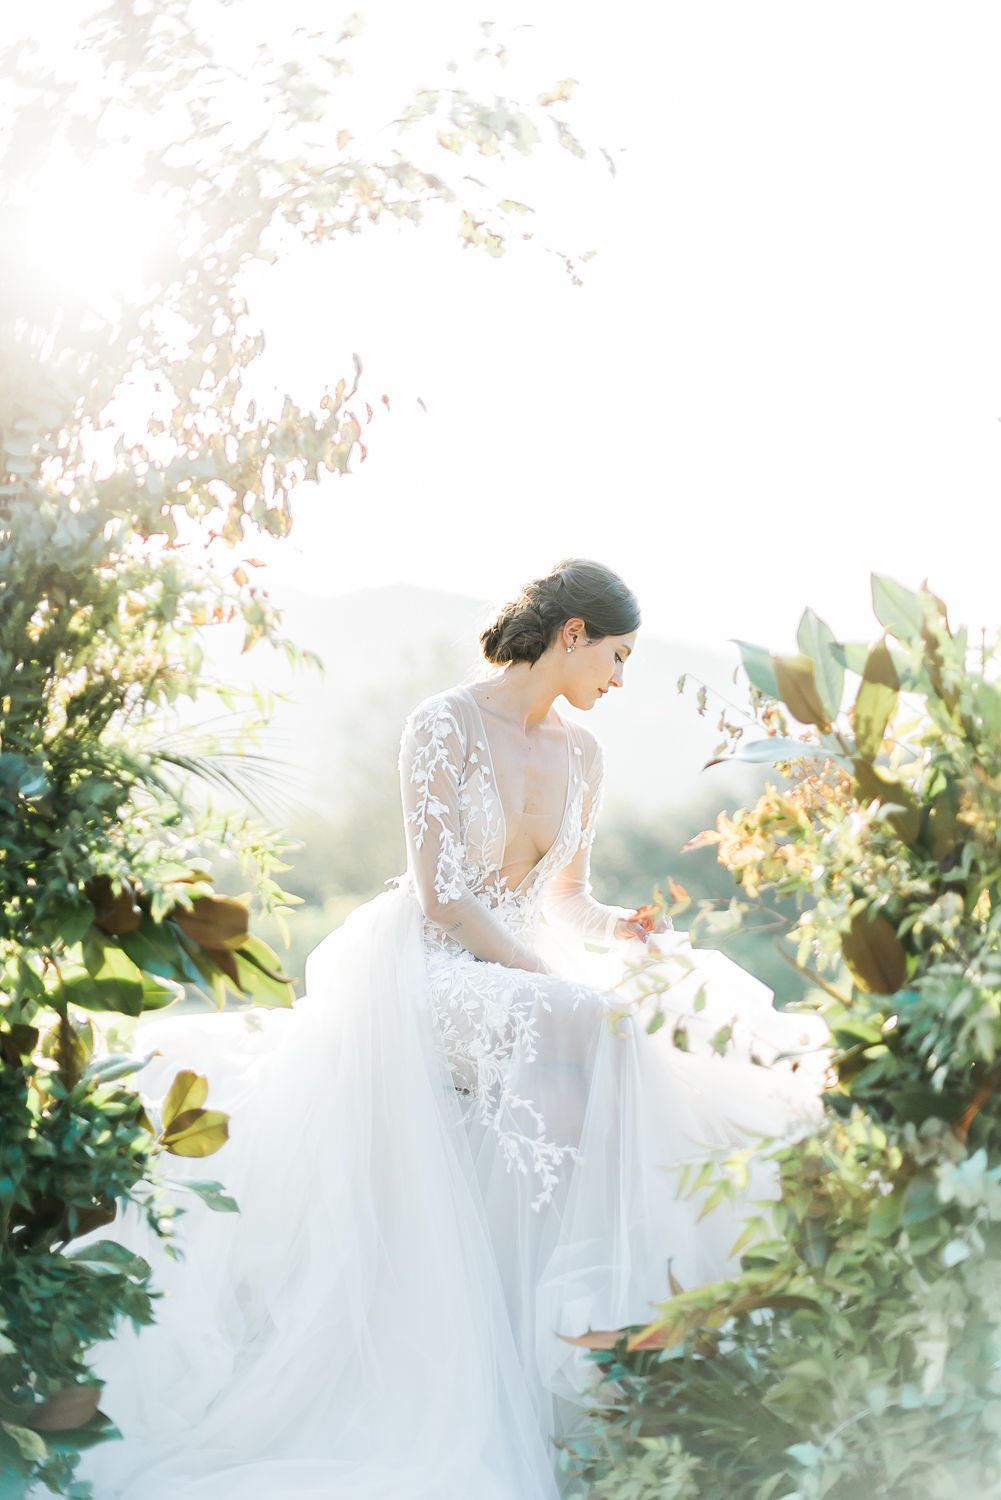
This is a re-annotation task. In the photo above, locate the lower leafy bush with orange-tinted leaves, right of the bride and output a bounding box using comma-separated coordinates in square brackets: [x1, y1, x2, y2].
[567, 578, 1001, 1500]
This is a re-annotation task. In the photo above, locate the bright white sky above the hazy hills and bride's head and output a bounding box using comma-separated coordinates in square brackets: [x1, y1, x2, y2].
[11, 0, 1001, 648]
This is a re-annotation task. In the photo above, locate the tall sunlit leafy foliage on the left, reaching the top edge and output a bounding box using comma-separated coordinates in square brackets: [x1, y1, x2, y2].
[0, 0, 591, 1500]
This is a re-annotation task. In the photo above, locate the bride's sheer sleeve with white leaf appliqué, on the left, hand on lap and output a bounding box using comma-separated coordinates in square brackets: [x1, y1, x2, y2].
[399, 699, 543, 971]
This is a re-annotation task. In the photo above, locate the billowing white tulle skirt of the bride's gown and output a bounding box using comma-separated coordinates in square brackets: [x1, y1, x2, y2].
[83, 882, 821, 1500]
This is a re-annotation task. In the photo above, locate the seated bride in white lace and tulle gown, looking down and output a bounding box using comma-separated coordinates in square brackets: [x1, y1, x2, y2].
[84, 560, 810, 1500]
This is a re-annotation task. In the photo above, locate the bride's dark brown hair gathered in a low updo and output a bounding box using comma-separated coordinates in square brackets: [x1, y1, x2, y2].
[480, 558, 639, 666]
